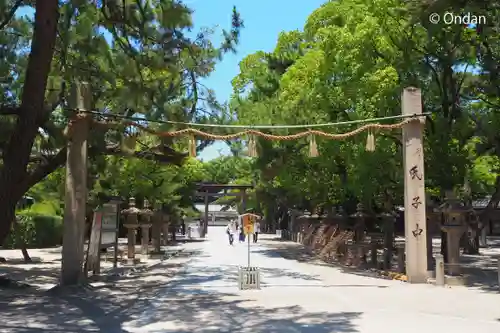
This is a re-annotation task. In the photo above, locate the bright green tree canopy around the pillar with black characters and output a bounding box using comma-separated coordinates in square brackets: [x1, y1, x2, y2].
[230, 0, 500, 215]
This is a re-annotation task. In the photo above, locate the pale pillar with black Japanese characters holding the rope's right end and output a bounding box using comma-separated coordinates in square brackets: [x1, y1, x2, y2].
[402, 87, 428, 283]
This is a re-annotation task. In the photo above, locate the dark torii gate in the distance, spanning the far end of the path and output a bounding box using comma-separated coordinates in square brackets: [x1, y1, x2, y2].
[195, 183, 254, 237]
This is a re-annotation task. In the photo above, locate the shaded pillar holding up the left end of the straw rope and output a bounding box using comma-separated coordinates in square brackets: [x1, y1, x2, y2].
[60, 83, 92, 285]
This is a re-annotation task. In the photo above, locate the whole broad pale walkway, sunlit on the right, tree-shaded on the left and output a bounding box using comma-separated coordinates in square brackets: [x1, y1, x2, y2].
[0, 227, 500, 333]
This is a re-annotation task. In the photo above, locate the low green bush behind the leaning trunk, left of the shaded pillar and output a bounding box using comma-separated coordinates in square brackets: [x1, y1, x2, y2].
[3, 211, 63, 249]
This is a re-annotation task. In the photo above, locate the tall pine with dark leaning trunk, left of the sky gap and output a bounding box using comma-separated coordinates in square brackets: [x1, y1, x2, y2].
[0, 0, 242, 243]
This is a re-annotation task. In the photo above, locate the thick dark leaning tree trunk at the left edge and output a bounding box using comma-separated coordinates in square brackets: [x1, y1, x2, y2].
[0, 0, 59, 244]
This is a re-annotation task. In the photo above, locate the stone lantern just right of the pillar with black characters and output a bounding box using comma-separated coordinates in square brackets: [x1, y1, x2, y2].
[439, 193, 469, 276]
